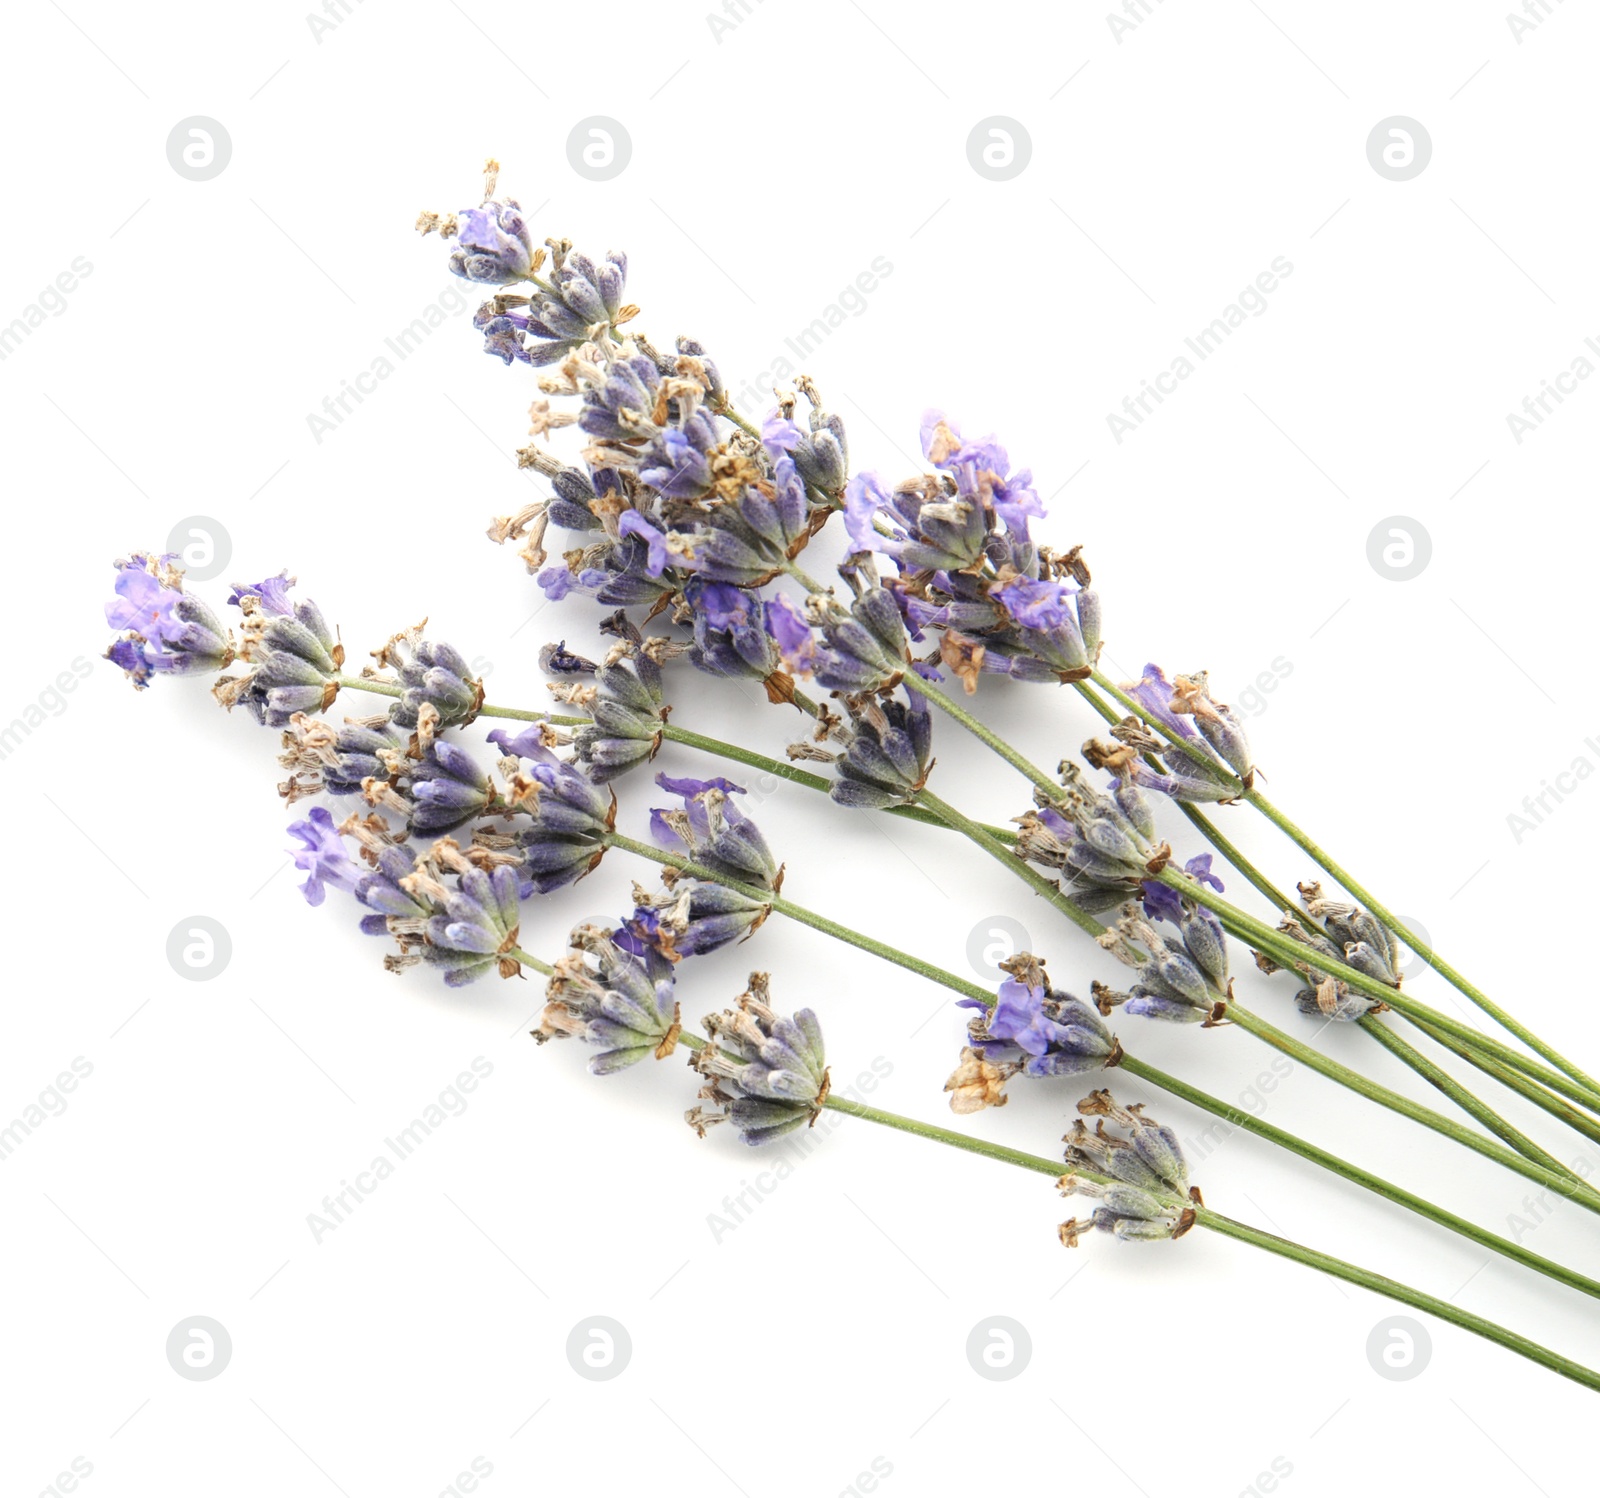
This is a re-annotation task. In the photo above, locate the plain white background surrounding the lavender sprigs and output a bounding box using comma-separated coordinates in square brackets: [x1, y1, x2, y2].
[0, 0, 1600, 1498]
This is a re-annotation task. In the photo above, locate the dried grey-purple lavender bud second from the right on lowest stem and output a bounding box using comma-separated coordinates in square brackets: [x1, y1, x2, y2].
[685, 973, 829, 1144]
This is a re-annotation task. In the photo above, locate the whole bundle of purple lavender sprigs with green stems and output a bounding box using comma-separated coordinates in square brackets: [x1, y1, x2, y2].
[96, 163, 1600, 1389]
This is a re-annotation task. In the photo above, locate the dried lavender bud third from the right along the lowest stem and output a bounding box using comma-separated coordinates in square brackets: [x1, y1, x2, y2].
[533, 927, 678, 1077]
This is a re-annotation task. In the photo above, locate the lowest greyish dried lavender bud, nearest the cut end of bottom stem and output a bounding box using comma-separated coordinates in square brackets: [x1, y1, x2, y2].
[1058, 1091, 1198, 1248]
